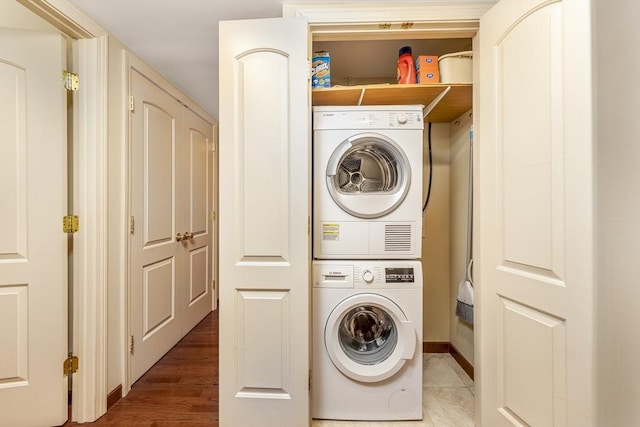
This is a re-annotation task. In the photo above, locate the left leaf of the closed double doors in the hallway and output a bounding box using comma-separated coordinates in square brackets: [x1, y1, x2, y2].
[129, 68, 181, 384]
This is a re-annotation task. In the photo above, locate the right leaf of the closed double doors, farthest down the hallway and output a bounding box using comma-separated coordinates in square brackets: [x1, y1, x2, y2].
[177, 107, 214, 335]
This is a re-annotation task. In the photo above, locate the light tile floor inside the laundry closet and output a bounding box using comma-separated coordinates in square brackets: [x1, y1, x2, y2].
[311, 353, 475, 427]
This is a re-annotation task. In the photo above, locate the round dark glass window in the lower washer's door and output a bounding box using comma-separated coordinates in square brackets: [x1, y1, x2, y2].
[338, 305, 398, 365]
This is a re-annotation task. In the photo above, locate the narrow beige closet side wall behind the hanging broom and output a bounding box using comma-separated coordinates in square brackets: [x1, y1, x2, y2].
[449, 111, 473, 364]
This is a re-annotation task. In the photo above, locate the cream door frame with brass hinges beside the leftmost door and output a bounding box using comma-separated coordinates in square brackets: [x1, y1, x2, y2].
[17, 0, 108, 422]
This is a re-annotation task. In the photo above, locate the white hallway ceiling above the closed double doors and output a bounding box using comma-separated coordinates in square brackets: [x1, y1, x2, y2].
[70, 0, 412, 118]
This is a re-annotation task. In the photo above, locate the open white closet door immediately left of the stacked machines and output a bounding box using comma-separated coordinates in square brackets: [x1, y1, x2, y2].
[219, 18, 311, 427]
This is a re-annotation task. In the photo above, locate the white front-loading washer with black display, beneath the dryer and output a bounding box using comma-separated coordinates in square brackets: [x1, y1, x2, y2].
[311, 260, 422, 420]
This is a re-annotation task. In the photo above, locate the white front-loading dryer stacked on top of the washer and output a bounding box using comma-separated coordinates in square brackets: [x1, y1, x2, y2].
[313, 105, 424, 259]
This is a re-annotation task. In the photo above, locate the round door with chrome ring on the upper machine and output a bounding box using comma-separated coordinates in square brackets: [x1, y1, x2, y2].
[326, 133, 411, 219]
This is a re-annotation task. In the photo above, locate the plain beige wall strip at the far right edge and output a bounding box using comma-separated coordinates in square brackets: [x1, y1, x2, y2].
[585, 0, 640, 427]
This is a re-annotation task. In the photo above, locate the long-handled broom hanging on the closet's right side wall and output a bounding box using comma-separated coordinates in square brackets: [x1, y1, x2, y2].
[456, 125, 473, 325]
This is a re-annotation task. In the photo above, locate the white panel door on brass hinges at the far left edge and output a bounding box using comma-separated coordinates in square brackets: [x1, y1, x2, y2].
[0, 28, 68, 427]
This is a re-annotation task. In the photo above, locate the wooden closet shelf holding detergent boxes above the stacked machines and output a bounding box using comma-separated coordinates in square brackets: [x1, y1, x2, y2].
[312, 83, 473, 122]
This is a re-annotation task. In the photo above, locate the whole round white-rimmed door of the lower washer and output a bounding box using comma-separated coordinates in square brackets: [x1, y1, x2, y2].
[324, 294, 416, 383]
